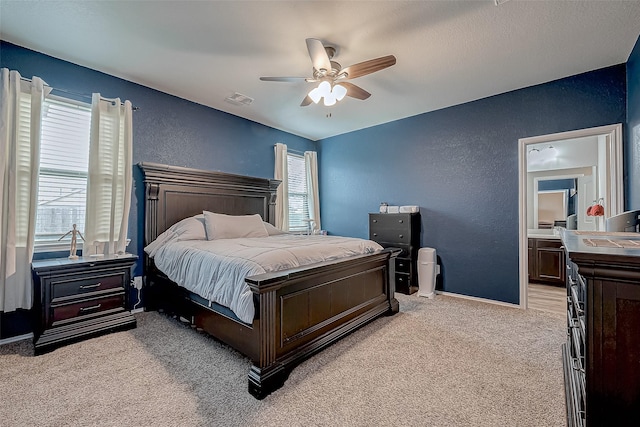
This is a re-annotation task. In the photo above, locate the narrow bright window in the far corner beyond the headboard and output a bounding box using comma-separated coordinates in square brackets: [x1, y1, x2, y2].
[287, 153, 309, 233]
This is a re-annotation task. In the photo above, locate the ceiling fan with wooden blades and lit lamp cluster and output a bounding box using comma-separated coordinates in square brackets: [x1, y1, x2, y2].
[260, 39, 396, 107]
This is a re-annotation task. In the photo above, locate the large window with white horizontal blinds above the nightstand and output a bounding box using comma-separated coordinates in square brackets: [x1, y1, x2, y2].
[35, 97, 91, 250]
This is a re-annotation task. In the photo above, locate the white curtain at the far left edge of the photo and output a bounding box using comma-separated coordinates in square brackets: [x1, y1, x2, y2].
[0, 68, 51, 312]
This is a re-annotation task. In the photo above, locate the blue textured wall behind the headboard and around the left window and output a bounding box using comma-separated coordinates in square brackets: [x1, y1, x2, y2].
[0, 41, 315, 275]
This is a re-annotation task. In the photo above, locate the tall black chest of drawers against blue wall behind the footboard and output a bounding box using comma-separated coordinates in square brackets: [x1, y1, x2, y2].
[369, 212, 421, 294]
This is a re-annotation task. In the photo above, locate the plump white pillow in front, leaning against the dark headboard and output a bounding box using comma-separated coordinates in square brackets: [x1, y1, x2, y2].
[204, 211, 269, 240]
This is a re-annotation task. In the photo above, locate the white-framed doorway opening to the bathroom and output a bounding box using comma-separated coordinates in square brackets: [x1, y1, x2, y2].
[518, 124, 624, 308]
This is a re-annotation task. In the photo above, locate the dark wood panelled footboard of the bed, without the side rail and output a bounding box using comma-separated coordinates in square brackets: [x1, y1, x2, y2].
[247, 251, 398, 398]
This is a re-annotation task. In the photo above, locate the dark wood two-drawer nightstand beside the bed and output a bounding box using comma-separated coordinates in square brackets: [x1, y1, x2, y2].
[31, 254, 138, 355]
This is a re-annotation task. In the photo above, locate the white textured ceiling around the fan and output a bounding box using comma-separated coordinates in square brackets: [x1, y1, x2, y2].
[0, 0, 640, 140]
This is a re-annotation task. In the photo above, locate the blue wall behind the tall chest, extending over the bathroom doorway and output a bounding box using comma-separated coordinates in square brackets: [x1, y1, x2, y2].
[319, 64, 626, 303]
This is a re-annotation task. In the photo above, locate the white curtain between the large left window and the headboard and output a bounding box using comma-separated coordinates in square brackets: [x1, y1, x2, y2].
[82, 93, 133, 256]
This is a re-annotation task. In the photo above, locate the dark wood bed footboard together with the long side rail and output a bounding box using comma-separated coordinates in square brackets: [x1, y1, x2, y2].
[147, 249, 399, 399]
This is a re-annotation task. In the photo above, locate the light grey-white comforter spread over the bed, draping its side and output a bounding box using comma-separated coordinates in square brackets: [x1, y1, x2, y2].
[148, 234, 382, 323]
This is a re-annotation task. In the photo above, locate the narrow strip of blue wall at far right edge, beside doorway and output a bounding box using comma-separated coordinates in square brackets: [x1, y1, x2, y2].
[624, 37, 640, 210]
